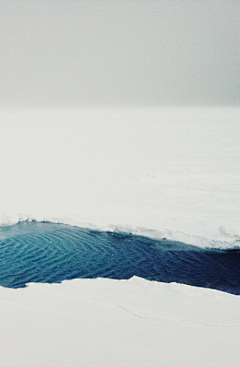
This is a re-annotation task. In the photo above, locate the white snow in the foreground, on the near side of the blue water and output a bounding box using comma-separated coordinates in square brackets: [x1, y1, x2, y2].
[0, 278, 240, 367]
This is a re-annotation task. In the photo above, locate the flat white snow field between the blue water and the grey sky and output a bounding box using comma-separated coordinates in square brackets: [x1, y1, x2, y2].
[0, 108, 240, 247]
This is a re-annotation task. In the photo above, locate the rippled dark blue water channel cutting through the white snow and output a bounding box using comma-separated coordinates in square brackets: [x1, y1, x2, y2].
[0, 222, 240, 294]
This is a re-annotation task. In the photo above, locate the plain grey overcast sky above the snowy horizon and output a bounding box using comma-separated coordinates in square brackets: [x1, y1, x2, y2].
[0, 0, 240, 107]
